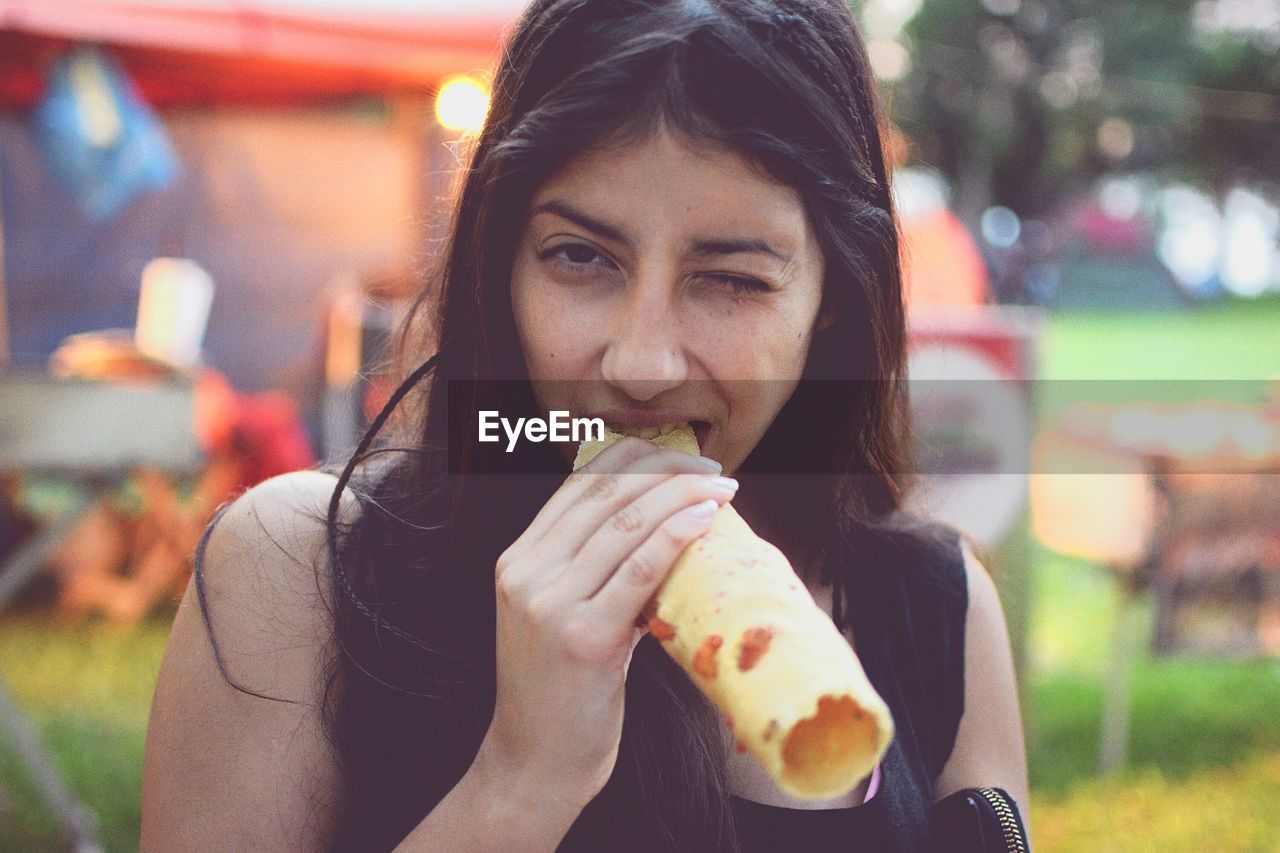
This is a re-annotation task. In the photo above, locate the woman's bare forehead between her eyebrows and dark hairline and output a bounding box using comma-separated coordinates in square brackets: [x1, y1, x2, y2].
[532, 131, 813, 255]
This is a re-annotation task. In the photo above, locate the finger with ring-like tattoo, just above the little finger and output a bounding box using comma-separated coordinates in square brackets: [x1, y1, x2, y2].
[557, 474, 736, 601]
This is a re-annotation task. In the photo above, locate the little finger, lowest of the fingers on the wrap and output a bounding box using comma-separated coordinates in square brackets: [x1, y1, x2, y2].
[588, 501, 719, 625]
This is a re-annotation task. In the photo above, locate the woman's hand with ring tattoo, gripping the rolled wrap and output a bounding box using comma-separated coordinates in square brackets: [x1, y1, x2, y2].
[481, 442, 733, 807]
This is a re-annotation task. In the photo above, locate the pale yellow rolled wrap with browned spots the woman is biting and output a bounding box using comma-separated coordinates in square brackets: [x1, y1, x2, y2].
[573, 424, 893, 799]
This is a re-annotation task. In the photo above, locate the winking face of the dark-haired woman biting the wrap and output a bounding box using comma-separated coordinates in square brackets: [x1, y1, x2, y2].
[511, 126, 827, 473]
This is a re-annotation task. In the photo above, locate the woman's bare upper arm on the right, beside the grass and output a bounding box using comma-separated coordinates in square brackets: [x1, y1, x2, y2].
[933, 537, 1029, 830]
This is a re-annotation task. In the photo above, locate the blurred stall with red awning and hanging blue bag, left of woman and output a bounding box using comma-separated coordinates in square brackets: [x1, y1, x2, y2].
[0, 0, 525, 849]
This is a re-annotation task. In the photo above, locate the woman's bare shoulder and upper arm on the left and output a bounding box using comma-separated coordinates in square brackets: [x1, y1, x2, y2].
[142, 471, 357, 850]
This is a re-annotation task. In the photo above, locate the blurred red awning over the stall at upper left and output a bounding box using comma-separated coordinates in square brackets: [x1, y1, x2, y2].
[0, 0, 526, 108]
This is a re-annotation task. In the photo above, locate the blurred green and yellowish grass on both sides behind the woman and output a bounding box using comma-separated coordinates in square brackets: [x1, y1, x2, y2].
[0, 298, 1280, 853]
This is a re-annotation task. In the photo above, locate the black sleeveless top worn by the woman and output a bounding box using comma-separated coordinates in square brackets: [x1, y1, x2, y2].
[332, 494, 968, 853]
